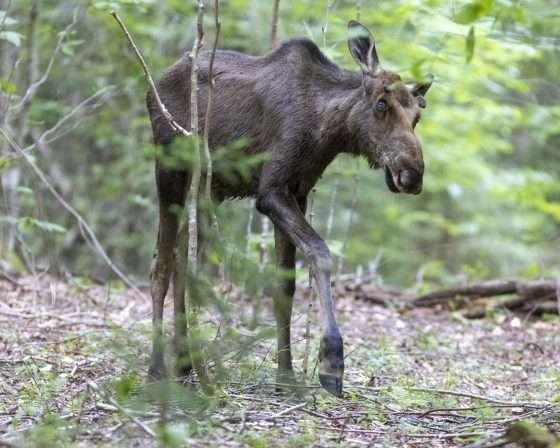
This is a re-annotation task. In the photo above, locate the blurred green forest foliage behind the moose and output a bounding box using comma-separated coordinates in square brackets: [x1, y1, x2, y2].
[0, 0, 560, 289]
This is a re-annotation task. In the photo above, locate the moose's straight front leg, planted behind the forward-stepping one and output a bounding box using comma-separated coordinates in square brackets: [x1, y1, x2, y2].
[274, 226, 296, 384]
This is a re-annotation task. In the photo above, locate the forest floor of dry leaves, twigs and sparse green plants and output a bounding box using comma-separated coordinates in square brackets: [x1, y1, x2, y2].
[0, 276, 560, 447]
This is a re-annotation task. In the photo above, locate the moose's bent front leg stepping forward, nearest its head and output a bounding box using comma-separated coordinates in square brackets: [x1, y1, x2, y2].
[257, 189, 344, 396]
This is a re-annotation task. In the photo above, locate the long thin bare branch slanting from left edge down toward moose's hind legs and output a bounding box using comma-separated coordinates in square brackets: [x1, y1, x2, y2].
[0, 128, 145, 298]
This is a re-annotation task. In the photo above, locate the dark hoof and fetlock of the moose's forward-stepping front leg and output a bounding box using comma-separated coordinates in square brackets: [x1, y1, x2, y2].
[319, 331, 344, 397]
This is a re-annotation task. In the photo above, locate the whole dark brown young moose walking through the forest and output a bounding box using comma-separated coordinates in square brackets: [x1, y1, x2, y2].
[147, 21, 432, 396]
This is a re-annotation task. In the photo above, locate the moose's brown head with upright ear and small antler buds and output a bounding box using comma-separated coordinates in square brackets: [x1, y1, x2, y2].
[348, 20, 433, 194]
